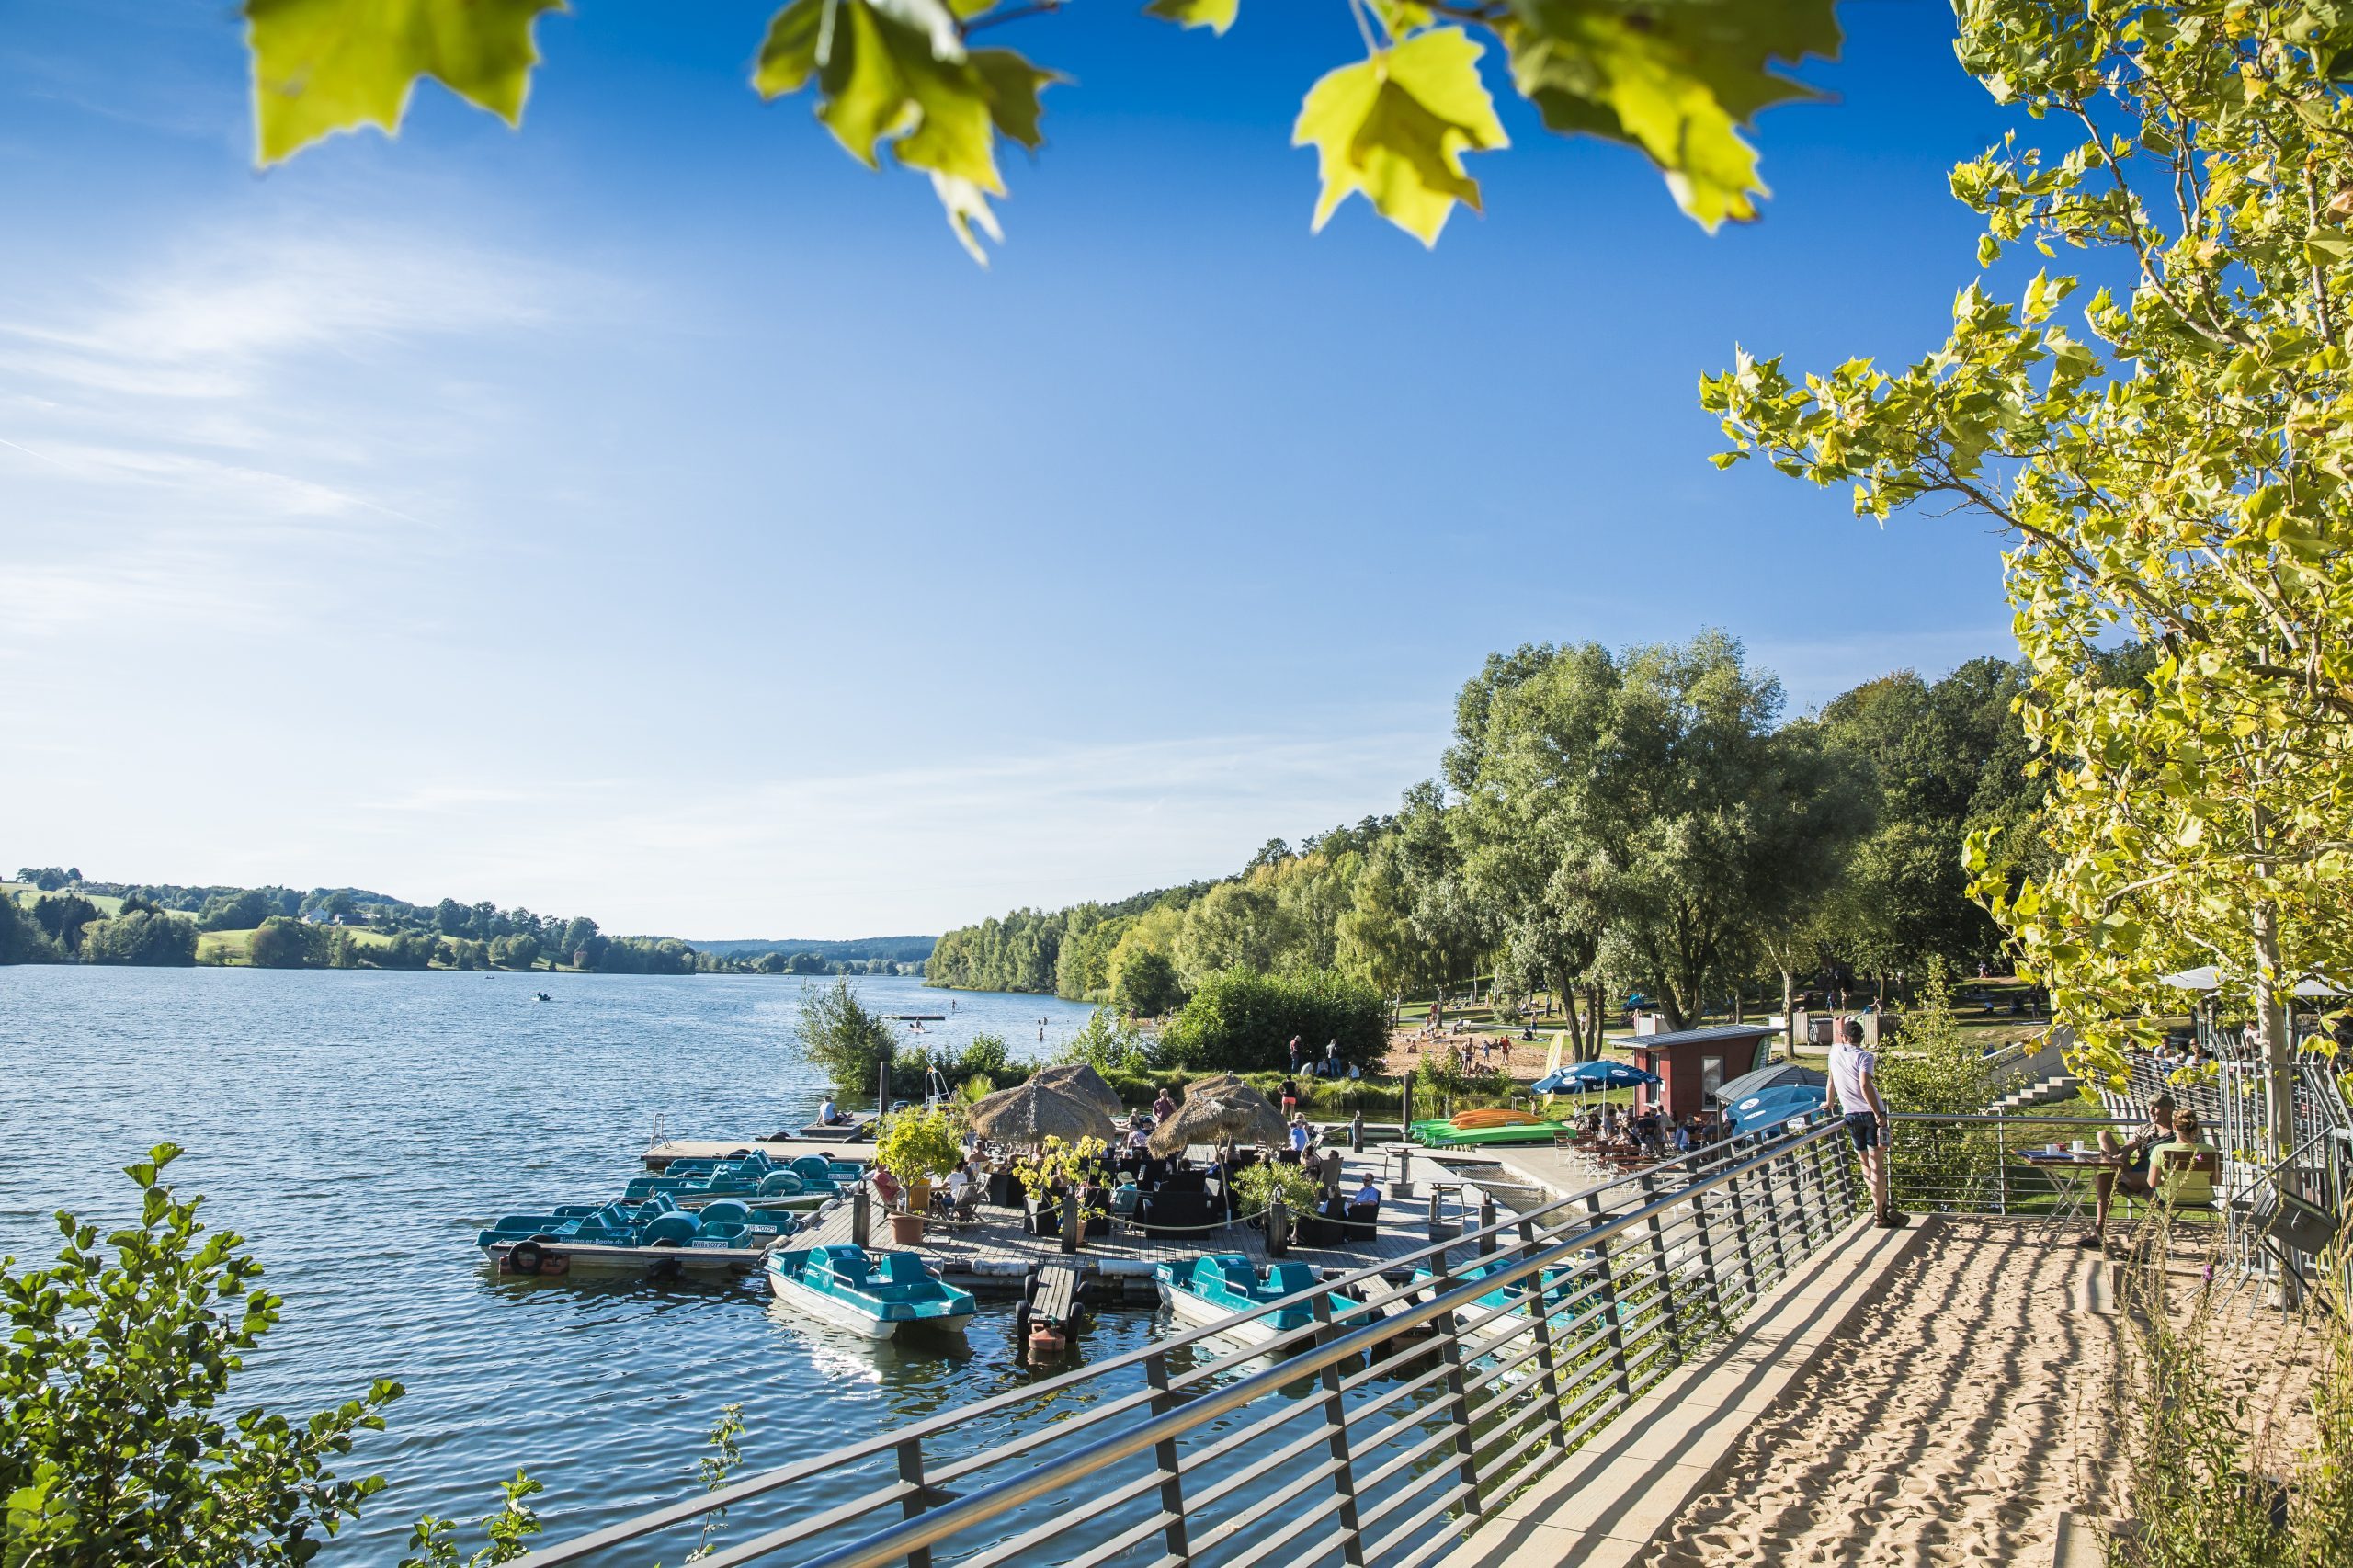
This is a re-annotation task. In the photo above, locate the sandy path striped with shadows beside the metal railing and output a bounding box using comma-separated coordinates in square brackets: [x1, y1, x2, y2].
[1640, 1220, 2113, 1568]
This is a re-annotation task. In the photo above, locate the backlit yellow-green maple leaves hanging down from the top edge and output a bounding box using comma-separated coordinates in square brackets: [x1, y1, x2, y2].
[243, 0, 1840, 264]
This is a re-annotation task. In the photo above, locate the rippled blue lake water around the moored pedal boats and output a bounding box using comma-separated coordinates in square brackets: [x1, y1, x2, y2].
[0, 968, 1115, 1563]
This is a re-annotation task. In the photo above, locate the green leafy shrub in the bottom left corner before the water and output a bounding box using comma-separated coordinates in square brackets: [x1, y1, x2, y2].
[0, 1144, 400, 1568]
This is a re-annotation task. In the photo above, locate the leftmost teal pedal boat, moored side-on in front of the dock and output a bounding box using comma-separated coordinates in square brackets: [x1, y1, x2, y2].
[475, 1196, 800, 1278]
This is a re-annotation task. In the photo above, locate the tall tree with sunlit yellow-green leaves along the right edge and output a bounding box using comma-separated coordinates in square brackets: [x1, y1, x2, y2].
[1701, 0, 2353, 1149]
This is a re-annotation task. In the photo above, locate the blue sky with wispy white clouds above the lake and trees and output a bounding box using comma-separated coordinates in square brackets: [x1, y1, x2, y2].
[0, 0, 2009, 937]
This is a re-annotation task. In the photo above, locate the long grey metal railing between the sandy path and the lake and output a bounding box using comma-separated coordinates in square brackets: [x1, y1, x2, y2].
[529, 1123, 1859, 1568]
